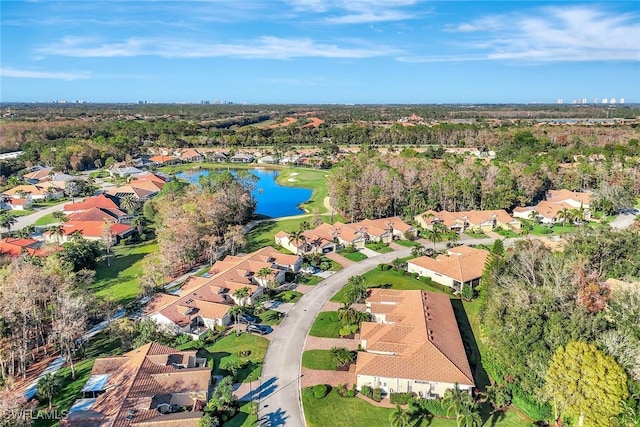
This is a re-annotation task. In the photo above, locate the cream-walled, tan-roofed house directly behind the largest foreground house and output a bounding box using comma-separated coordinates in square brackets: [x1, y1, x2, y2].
[407, 245, 489, 291]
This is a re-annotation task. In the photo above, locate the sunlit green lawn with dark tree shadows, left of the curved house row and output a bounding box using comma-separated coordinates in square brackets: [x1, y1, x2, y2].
[89, 241, 158, 305]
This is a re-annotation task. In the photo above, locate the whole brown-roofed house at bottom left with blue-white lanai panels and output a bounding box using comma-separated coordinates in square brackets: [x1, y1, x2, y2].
[60, 342, 211, 427]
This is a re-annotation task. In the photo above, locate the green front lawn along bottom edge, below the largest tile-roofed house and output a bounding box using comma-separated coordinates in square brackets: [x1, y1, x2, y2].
[302, 388, 531, 427]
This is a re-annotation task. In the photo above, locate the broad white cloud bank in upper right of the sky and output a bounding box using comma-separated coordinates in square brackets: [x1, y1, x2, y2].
[412, 5, 640, 63]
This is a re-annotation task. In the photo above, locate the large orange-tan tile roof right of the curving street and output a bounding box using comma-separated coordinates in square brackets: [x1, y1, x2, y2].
[356, 289, 474, 385]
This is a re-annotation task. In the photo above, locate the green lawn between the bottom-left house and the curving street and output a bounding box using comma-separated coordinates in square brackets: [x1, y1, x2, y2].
[198, 331, 269, 382]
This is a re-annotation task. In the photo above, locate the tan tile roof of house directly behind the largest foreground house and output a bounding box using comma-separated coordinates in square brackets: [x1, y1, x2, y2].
[408, 245, 489, 283]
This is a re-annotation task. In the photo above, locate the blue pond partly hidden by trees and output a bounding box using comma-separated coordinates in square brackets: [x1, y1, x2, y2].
[176, 169, 311, 218]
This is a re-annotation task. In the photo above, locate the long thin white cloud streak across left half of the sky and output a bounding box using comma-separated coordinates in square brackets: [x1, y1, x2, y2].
[37, 36, 400, 60]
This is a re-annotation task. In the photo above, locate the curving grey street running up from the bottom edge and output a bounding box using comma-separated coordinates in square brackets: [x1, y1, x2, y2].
[258, 248, 411, 427]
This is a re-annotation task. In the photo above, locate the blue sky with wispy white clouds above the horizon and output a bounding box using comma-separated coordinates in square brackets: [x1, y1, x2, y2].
[0, 0, 640, 104]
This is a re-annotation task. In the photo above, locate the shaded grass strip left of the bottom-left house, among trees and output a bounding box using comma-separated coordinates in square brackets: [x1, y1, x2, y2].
[33, 331, 122, 427]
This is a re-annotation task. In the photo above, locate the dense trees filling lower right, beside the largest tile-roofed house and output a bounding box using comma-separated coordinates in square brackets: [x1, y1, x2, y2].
[481, 229, 640, 425]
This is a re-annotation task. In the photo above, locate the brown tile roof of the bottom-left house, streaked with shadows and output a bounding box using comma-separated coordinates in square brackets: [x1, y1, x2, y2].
[82, 342, 211, 427]
